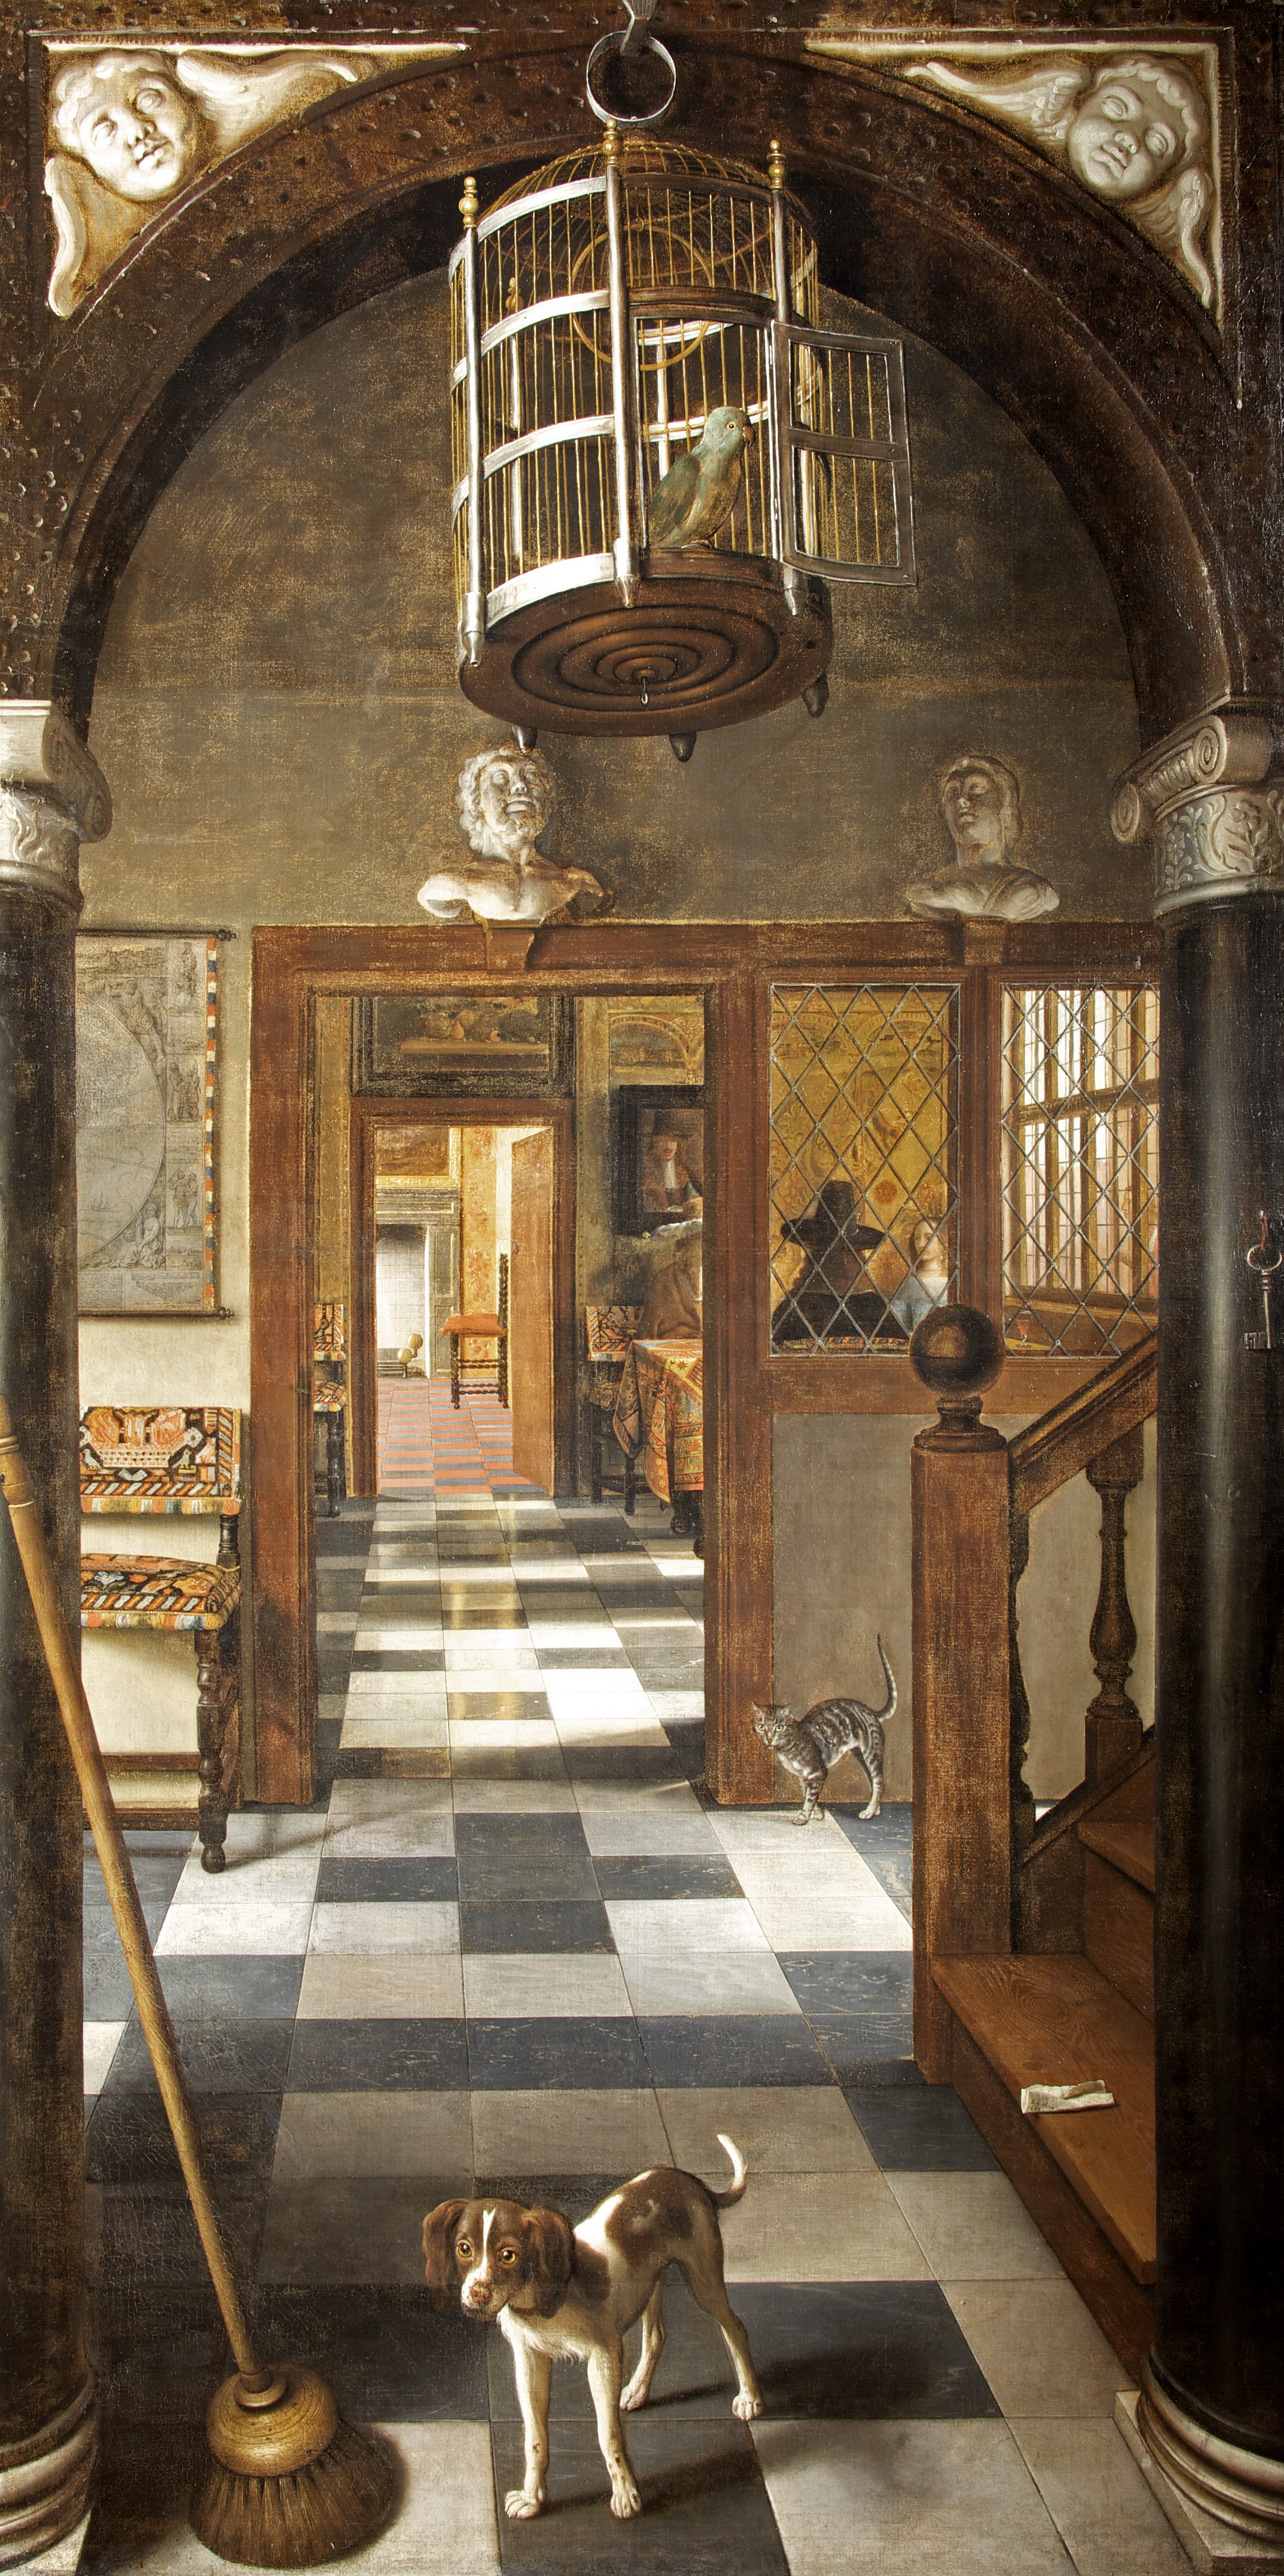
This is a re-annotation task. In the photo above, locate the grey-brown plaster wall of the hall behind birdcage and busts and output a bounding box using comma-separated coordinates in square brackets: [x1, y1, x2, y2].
[80, 256, 1147, 1796]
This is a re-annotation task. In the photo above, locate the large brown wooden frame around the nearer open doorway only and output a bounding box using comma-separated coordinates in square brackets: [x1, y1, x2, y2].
[250, 922, 773, 1806]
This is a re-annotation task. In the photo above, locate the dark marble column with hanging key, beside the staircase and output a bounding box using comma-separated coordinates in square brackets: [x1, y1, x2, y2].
[1117, 711, 1284, 2566]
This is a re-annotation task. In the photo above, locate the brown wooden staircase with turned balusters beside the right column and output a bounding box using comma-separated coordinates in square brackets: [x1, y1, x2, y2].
[915, 1345, 1155, 2370]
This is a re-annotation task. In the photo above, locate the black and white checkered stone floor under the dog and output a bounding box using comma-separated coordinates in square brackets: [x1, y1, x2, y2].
[85, 1489, 1186, 2576]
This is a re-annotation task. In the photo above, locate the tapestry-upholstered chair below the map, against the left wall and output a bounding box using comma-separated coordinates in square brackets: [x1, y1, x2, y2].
[80, 1404, 242, 1870]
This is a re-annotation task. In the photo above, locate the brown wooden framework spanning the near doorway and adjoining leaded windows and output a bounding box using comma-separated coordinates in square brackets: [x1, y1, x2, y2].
[250, 922, 1155, 1806]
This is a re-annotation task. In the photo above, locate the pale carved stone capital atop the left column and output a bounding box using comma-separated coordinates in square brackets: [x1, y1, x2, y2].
[0, 698, 111, 914]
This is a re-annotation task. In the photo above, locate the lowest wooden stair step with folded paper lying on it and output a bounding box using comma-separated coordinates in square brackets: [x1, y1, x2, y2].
[931, 1953, 1155, 2282]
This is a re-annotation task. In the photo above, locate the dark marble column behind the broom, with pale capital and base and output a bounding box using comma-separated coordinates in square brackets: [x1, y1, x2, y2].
[0, 698, 111, 2566]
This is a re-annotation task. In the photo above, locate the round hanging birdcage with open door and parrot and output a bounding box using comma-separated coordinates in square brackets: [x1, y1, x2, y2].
[451, 112, 915, 757]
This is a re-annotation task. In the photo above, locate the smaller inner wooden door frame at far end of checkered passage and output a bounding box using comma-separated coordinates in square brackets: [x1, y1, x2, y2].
[348, 1095, 575, 1494]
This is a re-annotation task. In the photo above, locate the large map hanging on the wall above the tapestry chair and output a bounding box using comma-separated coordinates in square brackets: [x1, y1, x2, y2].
[75, 930, 219, 1316]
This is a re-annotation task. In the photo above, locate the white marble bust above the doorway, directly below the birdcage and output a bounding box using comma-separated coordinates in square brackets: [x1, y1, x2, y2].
[418, 745, 609, 922]
